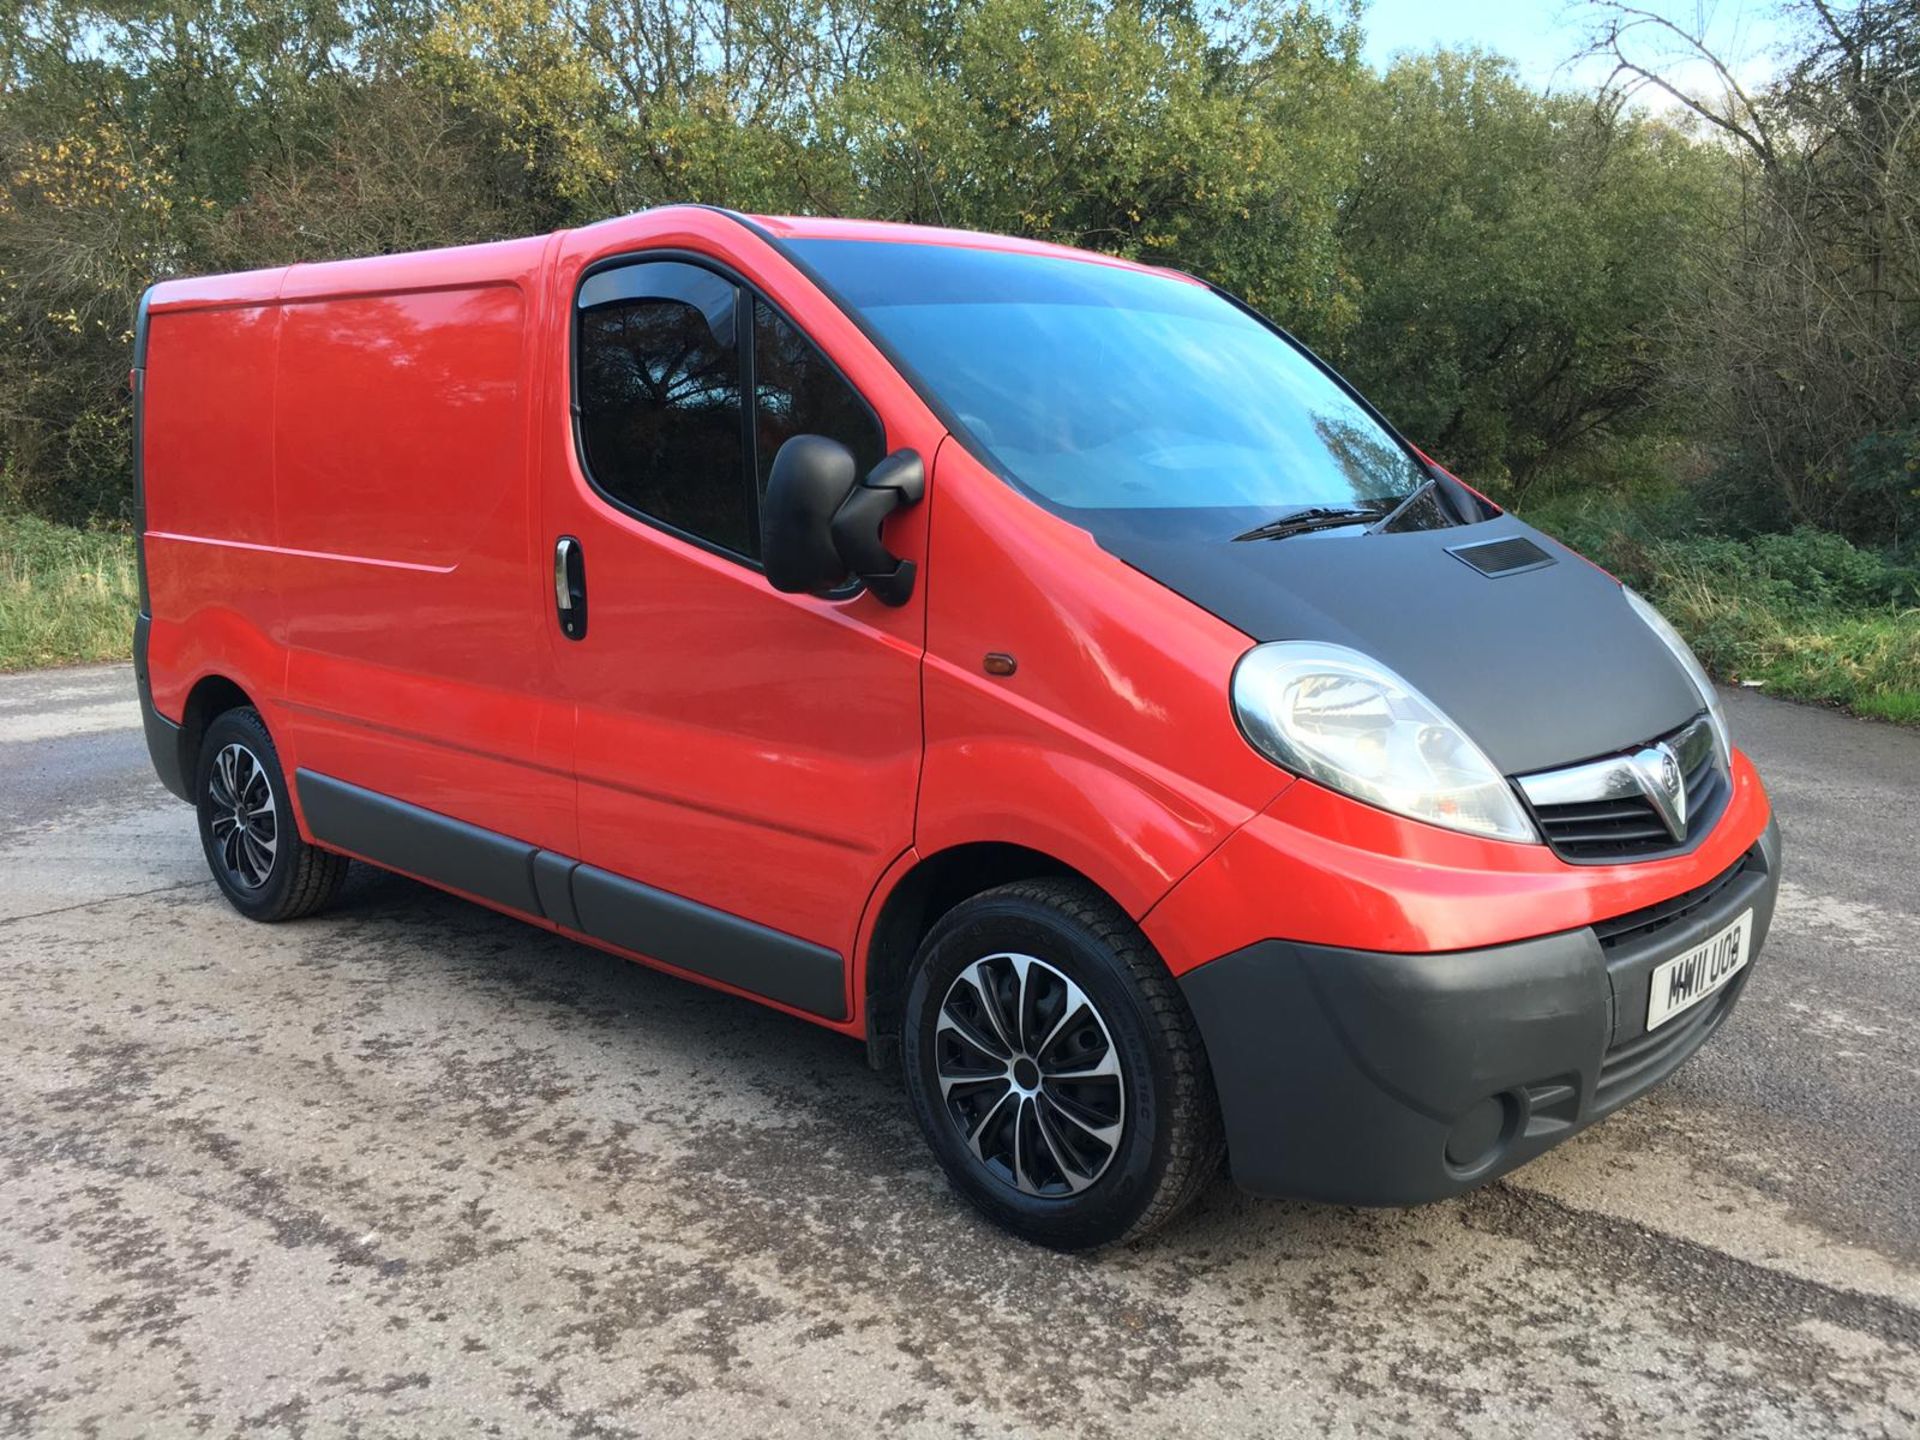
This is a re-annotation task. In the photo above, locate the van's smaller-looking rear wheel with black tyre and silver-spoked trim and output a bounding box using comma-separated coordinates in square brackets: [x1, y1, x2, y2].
[194, 708, 348, 922]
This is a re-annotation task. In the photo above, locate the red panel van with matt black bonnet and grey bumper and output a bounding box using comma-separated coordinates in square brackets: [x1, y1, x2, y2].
[132, 205, 1780, 1248]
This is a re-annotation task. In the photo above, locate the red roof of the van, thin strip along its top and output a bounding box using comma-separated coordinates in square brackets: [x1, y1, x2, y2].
[148, 205, 1169, 309]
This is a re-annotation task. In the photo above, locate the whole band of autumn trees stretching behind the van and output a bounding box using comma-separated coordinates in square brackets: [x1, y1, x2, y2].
[0, 0, 1920, 541]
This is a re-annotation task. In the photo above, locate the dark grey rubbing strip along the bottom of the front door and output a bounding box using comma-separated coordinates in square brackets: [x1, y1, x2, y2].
[574, 866, 847, 1020]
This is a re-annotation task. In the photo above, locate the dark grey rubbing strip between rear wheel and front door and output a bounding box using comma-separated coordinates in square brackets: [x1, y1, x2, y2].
[294, 770, 541, 916]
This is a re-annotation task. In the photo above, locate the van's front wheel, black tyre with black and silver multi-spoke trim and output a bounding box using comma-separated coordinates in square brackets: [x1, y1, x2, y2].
[902, 879, 1223, 1250]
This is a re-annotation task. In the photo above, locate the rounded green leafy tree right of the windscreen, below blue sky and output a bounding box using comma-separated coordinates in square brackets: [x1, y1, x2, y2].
[1336, 52, 1724, 499]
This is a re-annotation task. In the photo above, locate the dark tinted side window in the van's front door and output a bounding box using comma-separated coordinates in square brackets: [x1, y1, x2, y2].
[578, 261, 885, 561]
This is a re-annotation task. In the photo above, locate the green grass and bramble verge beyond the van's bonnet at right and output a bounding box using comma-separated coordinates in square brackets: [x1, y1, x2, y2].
[1526, 497, 1920, 726]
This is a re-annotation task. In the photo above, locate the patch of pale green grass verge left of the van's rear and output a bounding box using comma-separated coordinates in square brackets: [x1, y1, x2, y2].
[0, 515, 140, 670]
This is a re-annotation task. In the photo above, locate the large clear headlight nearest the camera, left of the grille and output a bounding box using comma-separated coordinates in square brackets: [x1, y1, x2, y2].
[1233, 639, 1538, 841]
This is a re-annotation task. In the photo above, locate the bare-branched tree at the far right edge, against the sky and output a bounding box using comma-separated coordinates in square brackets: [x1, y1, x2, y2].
[1597, 0, 1920, 543]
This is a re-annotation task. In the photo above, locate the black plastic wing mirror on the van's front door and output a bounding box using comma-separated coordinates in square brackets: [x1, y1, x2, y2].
[760, 436, 927, 605]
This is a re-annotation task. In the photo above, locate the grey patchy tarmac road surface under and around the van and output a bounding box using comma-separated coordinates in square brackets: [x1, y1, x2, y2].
[0, 666, 1920, 1440]
